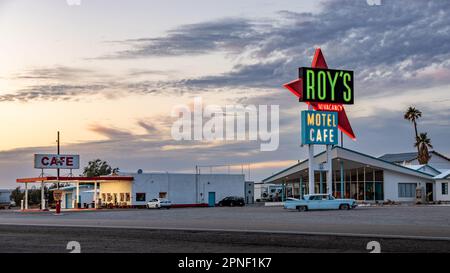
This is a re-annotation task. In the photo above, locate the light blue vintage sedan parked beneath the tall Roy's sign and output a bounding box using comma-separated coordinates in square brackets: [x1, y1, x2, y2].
[284, 194, 357, 211]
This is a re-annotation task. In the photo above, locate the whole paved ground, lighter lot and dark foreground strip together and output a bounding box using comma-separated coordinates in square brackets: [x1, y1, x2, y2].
[0, 206, 450, 252]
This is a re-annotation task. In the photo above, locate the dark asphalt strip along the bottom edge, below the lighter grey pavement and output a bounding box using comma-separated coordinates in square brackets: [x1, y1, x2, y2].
[0, 225, 450, 253]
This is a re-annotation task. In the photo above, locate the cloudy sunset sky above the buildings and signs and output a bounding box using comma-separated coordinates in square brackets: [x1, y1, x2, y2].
[0, 0, 450, 188]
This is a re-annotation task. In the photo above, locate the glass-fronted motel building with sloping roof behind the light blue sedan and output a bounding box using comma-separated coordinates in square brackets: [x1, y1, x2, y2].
[263, 146, 450, 203]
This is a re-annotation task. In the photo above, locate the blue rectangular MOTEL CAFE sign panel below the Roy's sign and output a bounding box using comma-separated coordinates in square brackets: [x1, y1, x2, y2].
[301, 111, 338, 145]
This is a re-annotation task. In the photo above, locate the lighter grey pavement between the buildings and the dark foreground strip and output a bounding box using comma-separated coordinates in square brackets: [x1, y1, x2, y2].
[0, 206, 450, 240]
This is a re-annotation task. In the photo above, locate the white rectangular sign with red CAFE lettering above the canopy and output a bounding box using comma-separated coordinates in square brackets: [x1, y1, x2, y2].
[34, 154, 80, 169]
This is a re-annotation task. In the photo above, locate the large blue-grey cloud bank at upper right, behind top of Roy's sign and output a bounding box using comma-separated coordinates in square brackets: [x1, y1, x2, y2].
[101, 0, 450, 95]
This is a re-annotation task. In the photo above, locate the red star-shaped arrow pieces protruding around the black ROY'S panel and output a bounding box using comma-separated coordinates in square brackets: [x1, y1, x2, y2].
[283, 48, 356, 140]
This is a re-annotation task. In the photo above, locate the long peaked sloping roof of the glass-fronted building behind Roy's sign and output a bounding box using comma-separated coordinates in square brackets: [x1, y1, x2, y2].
[263, 146, 433, 183]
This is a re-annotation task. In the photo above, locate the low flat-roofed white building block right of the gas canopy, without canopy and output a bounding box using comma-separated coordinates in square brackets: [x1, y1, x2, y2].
[99, 172, 245, 206]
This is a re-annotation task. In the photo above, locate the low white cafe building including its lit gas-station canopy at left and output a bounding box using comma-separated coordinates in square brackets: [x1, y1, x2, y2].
[16, 170, 246, 210]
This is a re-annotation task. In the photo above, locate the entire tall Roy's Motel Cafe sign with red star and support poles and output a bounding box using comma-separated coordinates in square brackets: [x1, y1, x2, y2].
[284, 48, 356, 194]
